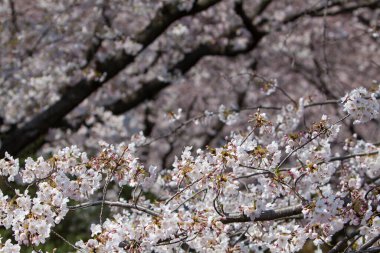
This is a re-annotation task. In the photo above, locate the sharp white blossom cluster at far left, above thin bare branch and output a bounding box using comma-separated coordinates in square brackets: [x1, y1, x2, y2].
[0, 143, 157, 250]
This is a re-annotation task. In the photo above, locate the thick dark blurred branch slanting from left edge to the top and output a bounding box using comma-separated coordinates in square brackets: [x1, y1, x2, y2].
[0, 0, 221, 157]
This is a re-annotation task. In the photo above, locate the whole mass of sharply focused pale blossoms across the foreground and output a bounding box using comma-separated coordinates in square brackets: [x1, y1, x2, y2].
[0, 89, 380, 252]
